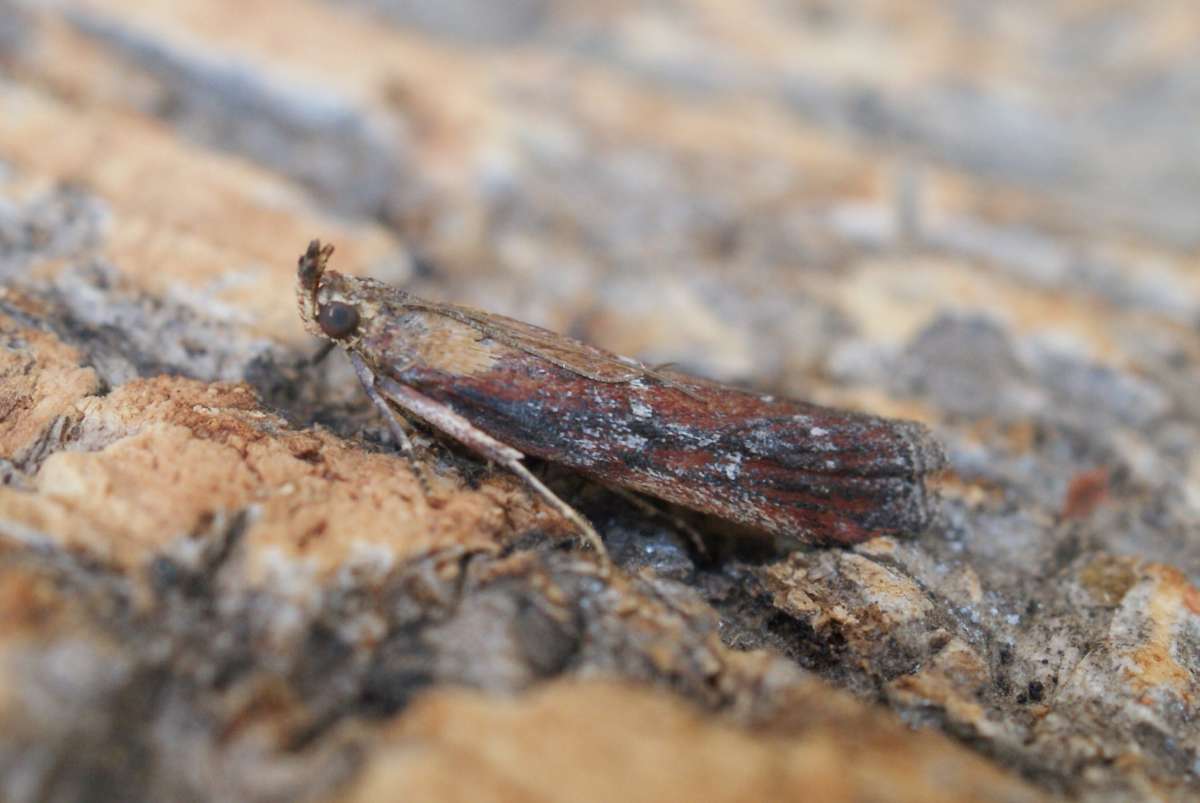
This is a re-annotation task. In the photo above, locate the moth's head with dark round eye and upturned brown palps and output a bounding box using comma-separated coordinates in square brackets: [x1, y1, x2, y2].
[296, 240, 374, 344]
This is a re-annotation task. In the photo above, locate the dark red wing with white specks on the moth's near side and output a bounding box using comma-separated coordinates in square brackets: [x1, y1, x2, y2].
[394, 343, 944, 543]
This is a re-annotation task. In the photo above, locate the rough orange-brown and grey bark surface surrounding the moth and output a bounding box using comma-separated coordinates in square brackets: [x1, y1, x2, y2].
[0, 0, 1200, 803]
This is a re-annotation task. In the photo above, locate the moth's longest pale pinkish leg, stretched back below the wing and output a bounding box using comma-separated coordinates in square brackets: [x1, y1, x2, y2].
[350, 354, 608, 561]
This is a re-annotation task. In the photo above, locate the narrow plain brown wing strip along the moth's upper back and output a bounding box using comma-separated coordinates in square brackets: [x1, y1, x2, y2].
[407, 302, 658, 383]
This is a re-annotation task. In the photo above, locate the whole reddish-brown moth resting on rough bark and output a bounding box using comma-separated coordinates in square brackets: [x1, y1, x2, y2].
[298, 240, 944, 555]
